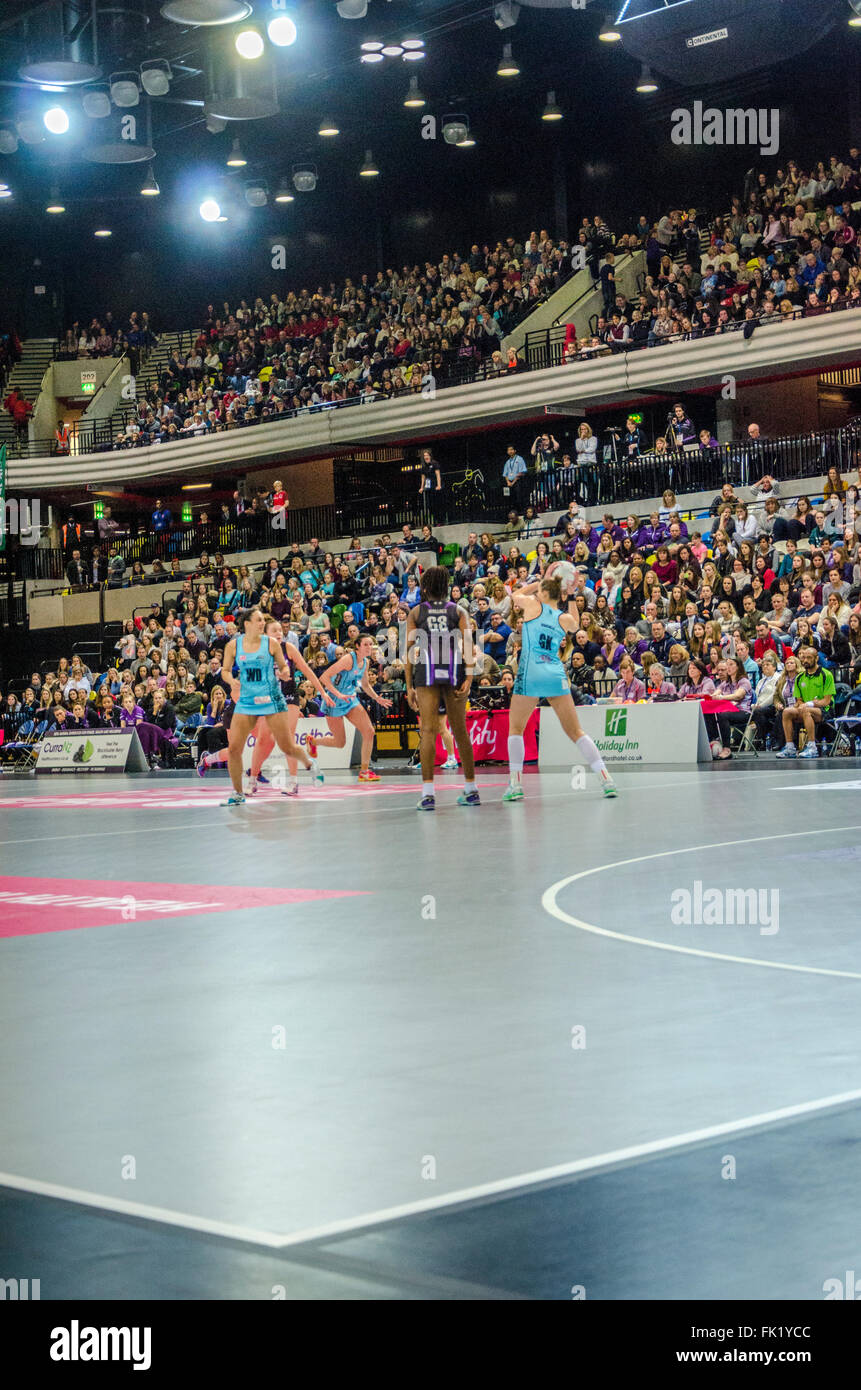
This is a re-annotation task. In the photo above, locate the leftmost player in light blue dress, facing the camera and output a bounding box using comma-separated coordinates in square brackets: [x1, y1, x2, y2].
[221, 607, 312, 806]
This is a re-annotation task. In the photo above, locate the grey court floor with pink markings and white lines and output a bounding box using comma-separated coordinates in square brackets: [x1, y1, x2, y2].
[0, 759, 861, 1300]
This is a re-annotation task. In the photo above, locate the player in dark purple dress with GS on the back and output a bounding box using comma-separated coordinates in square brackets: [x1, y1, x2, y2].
[405, 566, 481, 810]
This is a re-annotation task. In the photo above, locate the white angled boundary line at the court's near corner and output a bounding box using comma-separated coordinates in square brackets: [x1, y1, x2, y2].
[0, 1090, 861, 1250]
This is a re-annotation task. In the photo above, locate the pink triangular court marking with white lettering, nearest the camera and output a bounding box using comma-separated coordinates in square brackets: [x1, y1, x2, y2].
[0, 877, 364, 938]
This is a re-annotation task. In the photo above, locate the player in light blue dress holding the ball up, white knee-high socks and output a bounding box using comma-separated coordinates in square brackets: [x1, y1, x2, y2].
[502, 578, 616, 801]
